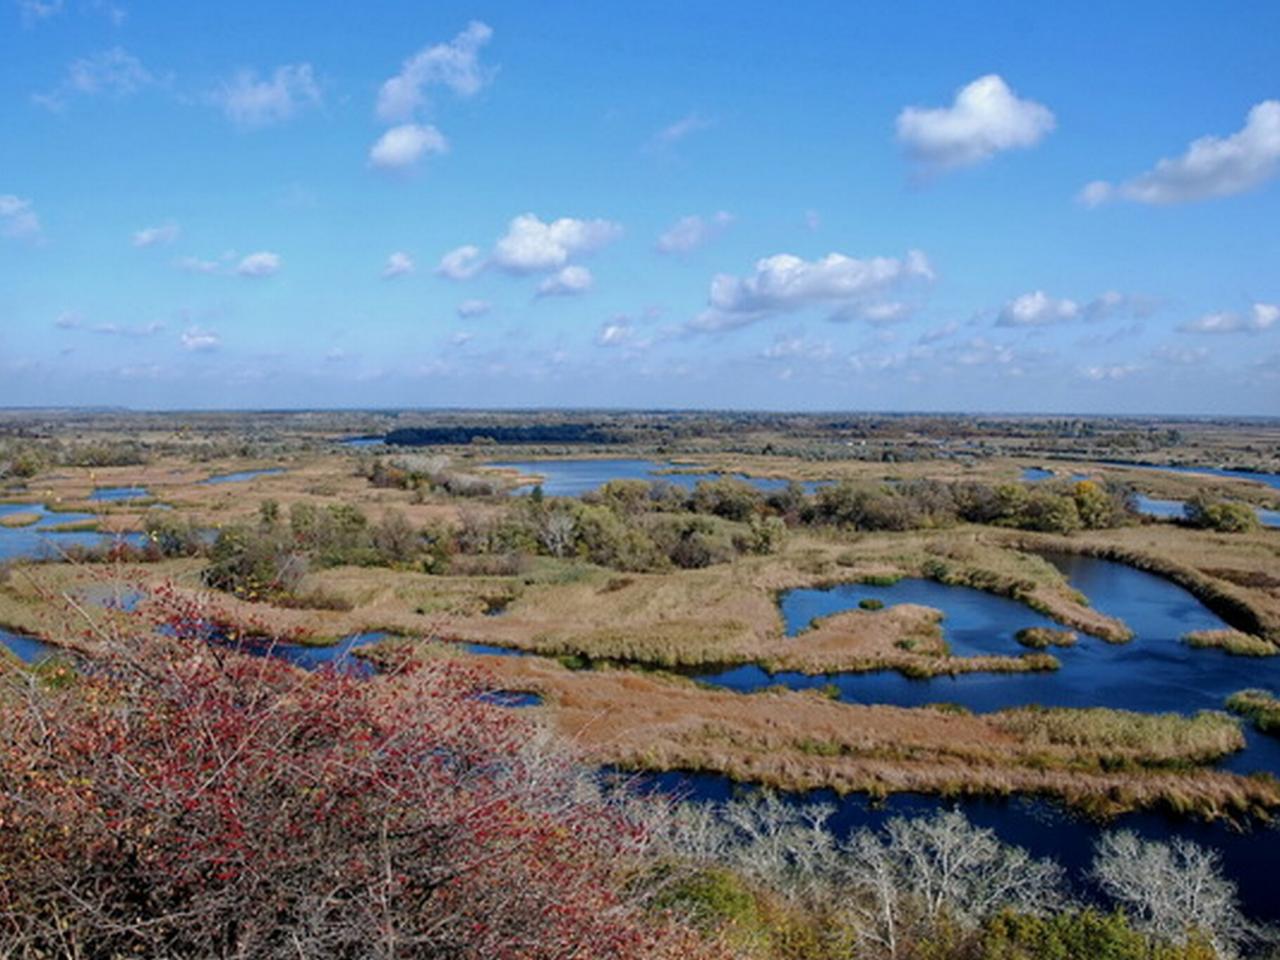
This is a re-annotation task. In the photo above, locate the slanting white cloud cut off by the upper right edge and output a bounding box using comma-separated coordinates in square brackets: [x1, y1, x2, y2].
[1078, 100, 1280, 206]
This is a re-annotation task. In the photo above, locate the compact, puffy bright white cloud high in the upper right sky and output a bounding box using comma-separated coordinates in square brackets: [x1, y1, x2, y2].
[897, 73, 1056, 170]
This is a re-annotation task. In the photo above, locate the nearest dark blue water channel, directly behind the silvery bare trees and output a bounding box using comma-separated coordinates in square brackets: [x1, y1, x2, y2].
[634, 773, 1280, 920]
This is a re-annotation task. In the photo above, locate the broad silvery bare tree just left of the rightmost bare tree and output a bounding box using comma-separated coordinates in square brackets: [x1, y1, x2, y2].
[840, 812, 1062, 957]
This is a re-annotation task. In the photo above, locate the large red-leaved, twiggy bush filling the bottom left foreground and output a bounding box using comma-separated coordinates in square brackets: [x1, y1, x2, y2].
[0, 593, 721, 960]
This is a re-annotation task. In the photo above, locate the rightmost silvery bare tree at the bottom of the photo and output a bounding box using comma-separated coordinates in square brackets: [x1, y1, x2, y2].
[1093, 831, 1258, 960]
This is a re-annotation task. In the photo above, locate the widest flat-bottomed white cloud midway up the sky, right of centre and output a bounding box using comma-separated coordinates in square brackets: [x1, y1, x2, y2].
[689, 250, 934, 332]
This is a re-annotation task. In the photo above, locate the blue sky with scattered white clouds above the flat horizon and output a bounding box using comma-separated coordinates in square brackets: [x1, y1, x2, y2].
[0, 0, 1280, 415]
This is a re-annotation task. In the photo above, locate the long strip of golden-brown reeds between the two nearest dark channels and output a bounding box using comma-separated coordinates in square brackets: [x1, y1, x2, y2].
[424, 657, 1280, 817]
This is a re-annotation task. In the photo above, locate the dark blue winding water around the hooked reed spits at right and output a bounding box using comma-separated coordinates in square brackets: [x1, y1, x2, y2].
[696, 556, 1280, 732]
